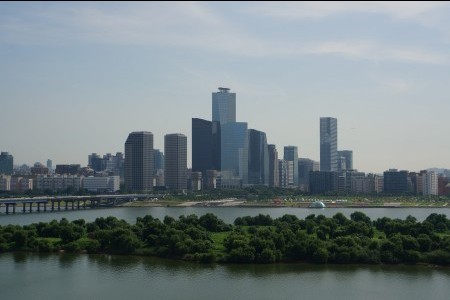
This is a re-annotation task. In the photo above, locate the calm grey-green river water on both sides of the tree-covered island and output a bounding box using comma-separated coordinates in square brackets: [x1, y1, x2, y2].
[0, 207, 450, 300]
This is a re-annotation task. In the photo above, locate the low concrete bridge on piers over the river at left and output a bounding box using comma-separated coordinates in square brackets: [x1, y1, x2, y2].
[0, 194, 162, 214]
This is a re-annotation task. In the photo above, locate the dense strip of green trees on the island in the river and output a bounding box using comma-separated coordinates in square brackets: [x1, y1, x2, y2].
[0, 212, 450, 265]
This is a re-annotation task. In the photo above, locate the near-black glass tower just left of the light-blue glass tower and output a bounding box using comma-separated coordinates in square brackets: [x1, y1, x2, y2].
[192, 118, 215, 178]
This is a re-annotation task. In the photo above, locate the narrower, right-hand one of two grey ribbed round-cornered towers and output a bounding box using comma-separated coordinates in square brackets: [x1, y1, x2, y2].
[164, 133, 187, 191]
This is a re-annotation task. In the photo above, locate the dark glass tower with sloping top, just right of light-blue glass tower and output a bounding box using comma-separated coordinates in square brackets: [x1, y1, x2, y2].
[248, 129, 269, 185]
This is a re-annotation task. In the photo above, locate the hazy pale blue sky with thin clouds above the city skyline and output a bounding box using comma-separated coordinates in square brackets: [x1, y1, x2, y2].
[0, 1, 450, 173]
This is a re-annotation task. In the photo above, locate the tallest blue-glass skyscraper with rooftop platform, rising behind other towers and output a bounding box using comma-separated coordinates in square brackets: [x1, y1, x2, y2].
[212, 87, 236, 125]
